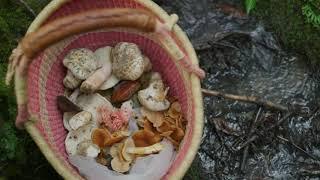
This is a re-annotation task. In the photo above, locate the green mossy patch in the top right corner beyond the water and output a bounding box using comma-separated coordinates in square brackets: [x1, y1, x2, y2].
[253, 0, 320, 64]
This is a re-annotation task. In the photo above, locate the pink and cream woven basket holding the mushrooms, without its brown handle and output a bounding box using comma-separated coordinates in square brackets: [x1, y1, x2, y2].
[7, 0, 203, 179]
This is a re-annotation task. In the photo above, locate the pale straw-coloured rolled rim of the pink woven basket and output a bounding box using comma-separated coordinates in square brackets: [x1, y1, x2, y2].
[23, 0, 204, 179]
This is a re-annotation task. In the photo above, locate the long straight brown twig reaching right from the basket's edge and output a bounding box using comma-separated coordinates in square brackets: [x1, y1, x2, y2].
[201, 89, 288, 111]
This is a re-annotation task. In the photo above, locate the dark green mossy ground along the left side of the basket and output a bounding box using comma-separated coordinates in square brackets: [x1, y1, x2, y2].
[0, 0, 59, 180]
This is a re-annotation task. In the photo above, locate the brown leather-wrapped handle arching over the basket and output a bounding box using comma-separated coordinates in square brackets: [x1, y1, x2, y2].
[6, 8, 159, 84]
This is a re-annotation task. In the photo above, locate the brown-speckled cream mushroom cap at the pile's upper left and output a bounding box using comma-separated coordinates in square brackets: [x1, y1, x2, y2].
[63, 48, 101, 80]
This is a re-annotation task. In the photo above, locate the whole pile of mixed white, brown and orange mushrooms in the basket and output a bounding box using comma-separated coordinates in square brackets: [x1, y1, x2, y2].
[57, 42, 186, 173]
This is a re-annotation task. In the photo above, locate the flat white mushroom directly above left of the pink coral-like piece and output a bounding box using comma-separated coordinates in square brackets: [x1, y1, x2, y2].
[76, 93, 113, 123]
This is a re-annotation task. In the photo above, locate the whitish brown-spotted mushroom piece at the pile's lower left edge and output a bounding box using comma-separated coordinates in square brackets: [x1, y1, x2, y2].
[65, 124, 95, 155]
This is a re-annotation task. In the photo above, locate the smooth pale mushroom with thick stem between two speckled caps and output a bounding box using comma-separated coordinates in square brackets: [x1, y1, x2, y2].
[80, 46, 112, 93]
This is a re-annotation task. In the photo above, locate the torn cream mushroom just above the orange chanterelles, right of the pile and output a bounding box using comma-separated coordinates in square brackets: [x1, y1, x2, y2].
[138, 80, 170, 111]
